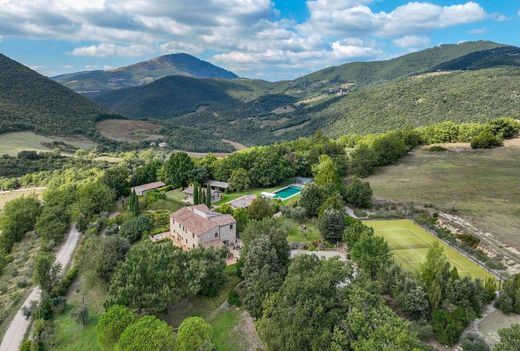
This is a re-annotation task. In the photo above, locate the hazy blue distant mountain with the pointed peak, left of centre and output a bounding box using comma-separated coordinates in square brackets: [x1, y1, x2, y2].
[52, 54, 238, 94]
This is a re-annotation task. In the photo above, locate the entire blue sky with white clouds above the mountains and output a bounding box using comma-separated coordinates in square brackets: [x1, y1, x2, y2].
[0, 0, 520, 80]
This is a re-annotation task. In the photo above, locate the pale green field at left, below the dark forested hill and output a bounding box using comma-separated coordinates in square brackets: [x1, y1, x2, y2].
[0, 132, 94, 156]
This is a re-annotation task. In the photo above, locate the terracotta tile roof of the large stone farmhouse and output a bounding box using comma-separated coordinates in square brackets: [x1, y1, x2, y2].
[171, 204, 236, 235]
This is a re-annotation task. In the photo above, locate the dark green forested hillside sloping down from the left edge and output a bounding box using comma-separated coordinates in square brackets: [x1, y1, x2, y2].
[0, 54, 105, 135]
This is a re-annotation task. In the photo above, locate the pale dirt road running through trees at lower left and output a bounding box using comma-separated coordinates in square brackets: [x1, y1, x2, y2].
[0, 225, 81, 351]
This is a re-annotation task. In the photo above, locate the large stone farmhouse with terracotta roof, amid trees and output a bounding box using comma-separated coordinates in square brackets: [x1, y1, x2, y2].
[170, 204, 237, 250]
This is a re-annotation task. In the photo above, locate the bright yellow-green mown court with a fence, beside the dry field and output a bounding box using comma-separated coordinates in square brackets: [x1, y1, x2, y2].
[364, 219, 494, 279]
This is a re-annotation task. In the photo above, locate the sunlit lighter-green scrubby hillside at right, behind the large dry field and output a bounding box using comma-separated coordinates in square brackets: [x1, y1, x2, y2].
[314, 67, 520, 136]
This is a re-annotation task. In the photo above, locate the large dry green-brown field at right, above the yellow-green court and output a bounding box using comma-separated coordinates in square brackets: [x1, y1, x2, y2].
[368, 139, 520, 250]
